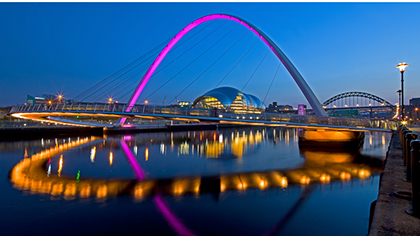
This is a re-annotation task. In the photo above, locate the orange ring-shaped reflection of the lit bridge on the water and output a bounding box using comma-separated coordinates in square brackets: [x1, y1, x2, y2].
[10, 129, 385, 201]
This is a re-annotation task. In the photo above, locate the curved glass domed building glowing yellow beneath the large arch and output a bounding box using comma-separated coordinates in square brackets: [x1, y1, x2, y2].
[192, 87, 265, 113]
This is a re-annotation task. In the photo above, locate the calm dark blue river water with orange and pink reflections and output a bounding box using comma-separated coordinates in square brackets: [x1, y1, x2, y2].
[0, 128, 391, 236]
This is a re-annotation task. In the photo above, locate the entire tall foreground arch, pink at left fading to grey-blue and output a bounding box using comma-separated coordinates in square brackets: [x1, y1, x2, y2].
[120, 14, 328, 123]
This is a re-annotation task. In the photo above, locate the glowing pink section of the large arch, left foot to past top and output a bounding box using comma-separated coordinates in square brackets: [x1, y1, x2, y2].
[121, 14, 279, 115]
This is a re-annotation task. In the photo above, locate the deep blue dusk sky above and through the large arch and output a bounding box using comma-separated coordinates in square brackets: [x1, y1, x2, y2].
[0, 3, 420, 107]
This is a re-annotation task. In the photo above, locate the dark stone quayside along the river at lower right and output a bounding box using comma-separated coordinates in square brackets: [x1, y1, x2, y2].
[369, 132, 420, 236]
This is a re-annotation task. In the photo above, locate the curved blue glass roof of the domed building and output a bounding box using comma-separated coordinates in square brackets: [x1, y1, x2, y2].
[192, 87, 265, 109]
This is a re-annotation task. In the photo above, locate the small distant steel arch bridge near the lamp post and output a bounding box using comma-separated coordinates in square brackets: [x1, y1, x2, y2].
[323, 92, 393, 107]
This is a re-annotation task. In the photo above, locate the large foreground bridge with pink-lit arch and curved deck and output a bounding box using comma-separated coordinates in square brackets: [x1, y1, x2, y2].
[10, 14, 397, 132]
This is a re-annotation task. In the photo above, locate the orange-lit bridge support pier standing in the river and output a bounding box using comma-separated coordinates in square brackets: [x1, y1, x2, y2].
[299, 129, 365, 149]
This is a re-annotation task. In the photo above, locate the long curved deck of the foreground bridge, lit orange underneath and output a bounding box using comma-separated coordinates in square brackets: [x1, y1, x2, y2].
[10, 103, 397, 132]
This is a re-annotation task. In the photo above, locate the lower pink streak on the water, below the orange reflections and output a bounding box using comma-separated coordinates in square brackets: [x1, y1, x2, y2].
[153, 194, 195, 236]
